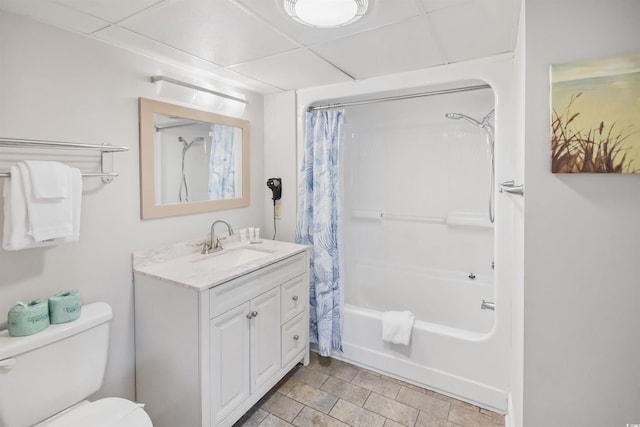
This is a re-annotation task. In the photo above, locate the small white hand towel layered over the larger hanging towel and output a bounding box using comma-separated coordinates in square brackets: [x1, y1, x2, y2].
[24, 160, 69, 199]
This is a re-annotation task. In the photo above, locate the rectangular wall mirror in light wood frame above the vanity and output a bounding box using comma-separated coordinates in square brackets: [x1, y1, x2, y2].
[140, 98, 249, 219]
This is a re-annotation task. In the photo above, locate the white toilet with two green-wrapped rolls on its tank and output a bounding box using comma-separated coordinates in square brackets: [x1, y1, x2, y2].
[0, 302, 152, 427]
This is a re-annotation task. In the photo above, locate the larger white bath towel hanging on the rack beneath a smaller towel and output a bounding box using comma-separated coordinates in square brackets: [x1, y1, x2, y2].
[2, 164, 82, 250]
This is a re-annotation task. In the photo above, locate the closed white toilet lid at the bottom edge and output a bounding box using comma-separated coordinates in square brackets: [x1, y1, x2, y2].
[42, 397, 152, 427]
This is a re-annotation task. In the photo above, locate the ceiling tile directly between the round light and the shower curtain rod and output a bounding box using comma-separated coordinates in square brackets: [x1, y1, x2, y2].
[312, 17, 444, 79]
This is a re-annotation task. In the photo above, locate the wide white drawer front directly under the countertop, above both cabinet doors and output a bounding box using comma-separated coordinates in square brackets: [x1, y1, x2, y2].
[209, 252, 307, 319]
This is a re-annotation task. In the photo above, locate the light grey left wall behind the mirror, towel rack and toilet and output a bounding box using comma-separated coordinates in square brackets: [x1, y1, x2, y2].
[0, 13, 266, 398]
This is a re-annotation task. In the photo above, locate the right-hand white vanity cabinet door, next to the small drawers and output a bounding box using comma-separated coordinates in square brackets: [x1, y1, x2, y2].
[250, 286, 280, 393]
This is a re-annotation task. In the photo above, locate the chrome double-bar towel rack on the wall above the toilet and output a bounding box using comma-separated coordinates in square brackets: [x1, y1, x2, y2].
[0, 138, 129, 183]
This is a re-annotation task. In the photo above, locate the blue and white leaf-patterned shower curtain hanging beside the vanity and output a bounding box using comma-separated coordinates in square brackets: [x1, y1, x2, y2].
[296, 110, 344, 356]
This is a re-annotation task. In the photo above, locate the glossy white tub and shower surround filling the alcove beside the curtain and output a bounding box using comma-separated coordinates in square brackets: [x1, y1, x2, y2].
[341, 83, 509, 411]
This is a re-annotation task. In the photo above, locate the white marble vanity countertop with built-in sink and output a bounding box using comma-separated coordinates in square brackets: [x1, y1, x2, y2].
[132, 239, 308, 291]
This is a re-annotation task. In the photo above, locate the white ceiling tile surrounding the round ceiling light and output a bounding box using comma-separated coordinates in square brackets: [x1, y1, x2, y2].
[238, 0, 422, 46]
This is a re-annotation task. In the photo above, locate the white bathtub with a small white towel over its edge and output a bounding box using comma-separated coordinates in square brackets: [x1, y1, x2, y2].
[336, 264, 509, 413]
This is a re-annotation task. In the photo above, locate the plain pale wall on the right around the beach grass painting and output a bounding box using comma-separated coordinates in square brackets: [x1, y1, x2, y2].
[524, 0, 640, 427]
